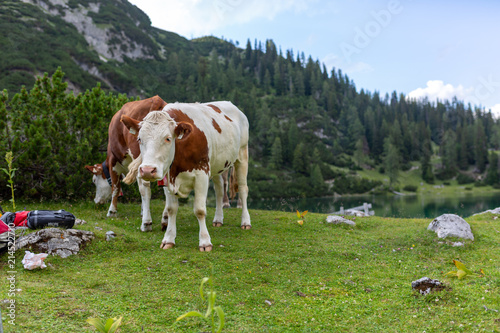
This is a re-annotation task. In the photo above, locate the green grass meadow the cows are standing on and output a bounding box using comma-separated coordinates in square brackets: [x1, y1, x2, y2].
[0, 200, 500, 333]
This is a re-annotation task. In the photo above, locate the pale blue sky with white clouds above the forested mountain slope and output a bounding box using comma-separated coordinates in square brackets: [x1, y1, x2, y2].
[129, 0, 500, 116]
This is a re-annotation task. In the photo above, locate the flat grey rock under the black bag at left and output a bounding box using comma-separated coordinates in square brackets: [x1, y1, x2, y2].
[16, 228, 95, 258]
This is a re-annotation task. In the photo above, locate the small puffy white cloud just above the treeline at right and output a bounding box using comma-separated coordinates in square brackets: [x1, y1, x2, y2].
[408, 80, 474, 102]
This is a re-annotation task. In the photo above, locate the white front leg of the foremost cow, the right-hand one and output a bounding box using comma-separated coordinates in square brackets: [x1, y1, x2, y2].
[193, 174, 212, 252]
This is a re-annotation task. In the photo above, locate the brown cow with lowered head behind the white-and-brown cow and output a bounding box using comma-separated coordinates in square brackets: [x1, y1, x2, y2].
[85, 96, 168, 231]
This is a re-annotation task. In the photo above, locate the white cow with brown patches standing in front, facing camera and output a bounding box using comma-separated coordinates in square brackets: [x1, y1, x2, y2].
[121, 102, 251, 252]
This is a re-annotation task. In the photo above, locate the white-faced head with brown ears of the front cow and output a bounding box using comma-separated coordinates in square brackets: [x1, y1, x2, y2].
[121, 111, 193, 181]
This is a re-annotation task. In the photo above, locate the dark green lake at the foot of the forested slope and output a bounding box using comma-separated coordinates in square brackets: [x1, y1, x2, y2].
[240, 192, 500, 218]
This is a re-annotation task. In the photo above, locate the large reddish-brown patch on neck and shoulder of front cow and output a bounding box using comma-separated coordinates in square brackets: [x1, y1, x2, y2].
[167, 109, 210, 184]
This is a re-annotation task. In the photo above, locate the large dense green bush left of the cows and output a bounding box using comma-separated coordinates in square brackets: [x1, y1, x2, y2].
[0, 68, 132, 199]
